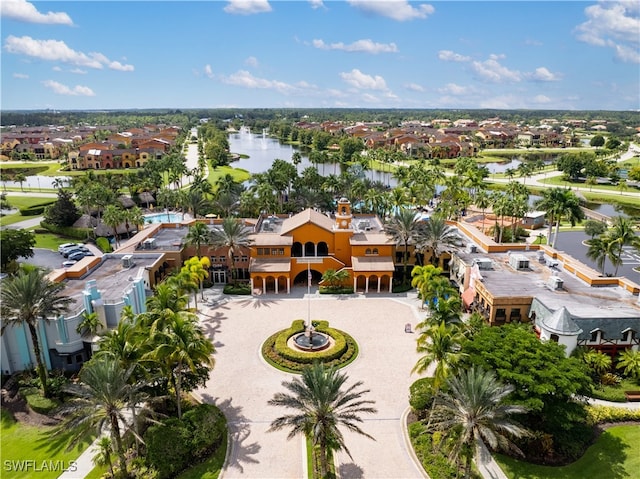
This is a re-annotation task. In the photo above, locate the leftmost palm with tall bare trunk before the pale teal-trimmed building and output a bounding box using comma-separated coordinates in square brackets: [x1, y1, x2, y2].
[0, 269, 73, 397]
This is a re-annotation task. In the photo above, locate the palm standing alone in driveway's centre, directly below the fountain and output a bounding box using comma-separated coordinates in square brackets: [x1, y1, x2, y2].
[269, 363, 377, 478]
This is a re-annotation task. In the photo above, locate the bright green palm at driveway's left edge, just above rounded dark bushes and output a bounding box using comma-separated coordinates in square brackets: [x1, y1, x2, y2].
[147, 313, 215, 418]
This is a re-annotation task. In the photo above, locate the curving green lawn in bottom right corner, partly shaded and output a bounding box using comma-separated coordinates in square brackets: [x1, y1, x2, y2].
[495, 425, 640, 479]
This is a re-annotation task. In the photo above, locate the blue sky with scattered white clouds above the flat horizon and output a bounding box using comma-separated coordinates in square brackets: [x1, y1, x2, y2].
[0, 0, 640, 110]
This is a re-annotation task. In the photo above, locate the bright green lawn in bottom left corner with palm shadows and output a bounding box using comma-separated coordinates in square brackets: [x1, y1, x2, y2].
[0, 409, 91, 479]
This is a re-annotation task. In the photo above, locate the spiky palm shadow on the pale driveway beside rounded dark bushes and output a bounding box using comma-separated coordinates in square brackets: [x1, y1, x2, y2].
[202, 394, 262, 473]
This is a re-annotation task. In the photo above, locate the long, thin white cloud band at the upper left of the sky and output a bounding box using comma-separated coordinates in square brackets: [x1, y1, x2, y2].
[4, 35, 134, 71]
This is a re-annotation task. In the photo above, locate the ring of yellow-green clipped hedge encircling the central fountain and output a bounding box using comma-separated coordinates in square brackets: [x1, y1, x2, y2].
[262, 319, 358, 372]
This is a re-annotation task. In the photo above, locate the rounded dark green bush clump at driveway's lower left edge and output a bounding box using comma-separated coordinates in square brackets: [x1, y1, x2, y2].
[144, 404, 227, 479]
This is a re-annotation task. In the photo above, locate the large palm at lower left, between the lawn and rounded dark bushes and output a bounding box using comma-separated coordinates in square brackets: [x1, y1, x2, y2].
[60, 356, 143, 476]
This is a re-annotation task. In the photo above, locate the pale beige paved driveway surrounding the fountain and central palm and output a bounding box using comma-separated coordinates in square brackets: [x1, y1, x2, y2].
[197, 295, 424, 479]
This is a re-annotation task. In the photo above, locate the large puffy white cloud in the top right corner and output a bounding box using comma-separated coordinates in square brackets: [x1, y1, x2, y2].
[575, 1, 640, 63]
